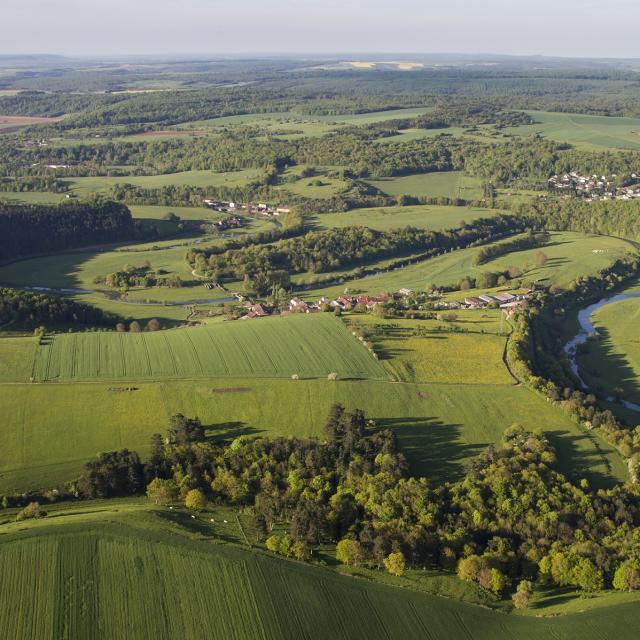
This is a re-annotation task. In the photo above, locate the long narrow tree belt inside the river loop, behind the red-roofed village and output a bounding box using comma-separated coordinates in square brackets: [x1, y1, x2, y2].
[188, 215, 526, 290]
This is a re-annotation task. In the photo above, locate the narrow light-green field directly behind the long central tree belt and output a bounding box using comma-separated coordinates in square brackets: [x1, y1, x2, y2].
[312, 205, 503, 231]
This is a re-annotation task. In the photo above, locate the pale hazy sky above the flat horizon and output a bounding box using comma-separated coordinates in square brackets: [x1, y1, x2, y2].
[5, 0, 640, 57]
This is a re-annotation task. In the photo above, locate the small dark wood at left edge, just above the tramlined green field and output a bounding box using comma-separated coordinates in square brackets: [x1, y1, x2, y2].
[0, 289, 116, 327]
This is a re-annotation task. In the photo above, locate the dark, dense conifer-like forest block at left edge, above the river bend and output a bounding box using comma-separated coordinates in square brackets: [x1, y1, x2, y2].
[0, 201, 136, 260]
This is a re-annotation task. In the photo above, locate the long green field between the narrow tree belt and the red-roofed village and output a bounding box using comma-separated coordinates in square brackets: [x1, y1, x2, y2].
[304, 232, 632, 297]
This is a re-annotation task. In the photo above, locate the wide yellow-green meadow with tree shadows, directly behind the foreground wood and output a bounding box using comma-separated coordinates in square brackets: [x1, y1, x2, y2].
[0, 372, 626, 493]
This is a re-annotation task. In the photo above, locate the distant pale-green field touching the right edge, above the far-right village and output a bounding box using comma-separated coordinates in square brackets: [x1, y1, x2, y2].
[503, 111, 640, 150]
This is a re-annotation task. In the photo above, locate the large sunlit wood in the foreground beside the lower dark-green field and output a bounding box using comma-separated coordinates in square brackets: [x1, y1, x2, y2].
[75, 405, 640, 606]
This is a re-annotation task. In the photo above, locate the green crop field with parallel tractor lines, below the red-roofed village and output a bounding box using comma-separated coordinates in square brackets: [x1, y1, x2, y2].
[34, 314, 388, 382]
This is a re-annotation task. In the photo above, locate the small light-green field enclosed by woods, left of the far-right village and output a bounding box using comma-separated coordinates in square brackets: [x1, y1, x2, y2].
[367, 171, 482, 200]
